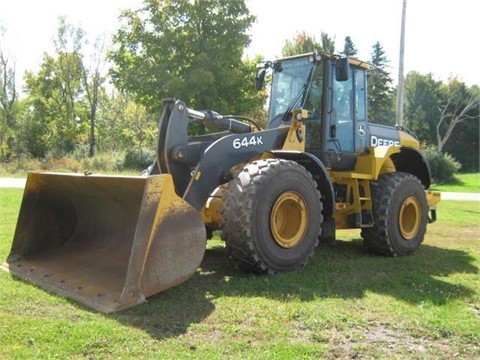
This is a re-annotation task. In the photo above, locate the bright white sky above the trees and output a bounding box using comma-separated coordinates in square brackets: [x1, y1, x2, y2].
[0, 0, 480, 85]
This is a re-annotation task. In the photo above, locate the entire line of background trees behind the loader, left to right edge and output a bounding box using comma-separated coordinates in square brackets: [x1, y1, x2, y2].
[0, 0, 480, 171]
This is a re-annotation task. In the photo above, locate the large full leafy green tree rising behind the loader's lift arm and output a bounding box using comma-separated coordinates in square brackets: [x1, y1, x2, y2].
[108, 0, 254, 113]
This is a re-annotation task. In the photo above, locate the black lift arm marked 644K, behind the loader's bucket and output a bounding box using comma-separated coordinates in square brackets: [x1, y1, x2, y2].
[157, 100, 289, 210]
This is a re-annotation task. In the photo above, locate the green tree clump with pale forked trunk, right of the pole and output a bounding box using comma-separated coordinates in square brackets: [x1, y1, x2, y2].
[405, 72, 480, 171]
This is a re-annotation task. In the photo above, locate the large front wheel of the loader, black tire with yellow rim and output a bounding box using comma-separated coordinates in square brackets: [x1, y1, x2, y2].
[222, 159, 323, 274]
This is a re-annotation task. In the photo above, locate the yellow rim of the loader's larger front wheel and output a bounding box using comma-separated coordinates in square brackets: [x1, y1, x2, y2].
[270, 191, 308, 248]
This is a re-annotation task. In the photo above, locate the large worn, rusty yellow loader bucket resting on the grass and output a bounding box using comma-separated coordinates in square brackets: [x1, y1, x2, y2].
[2, 172, 206, 313]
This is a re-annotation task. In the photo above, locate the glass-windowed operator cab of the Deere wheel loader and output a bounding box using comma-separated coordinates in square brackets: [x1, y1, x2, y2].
[257, 53, 369, 170]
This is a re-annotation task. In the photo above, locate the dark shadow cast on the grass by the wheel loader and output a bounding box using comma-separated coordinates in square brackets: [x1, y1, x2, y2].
[109, 239, 478, 339]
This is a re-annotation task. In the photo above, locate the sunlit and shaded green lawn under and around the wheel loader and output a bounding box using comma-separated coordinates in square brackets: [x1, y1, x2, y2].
[0, 189, 480, 359]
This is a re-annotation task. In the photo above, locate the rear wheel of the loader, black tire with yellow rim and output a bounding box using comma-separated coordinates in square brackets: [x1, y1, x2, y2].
[361, 172, 428, 256]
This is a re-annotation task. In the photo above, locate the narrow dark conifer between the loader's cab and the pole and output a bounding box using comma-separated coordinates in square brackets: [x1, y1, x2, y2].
[367, 41, 395, 125]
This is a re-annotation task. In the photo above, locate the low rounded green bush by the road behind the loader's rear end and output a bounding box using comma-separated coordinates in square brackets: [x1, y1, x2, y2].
[424, 146, 461, 184]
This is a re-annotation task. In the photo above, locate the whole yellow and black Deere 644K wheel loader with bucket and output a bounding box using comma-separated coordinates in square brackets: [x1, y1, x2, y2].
[2, 53, 440, 313]
